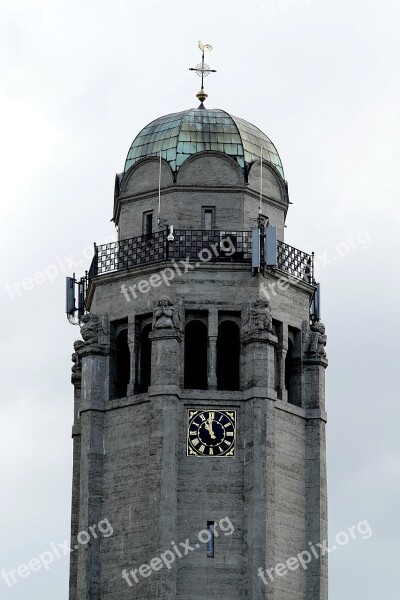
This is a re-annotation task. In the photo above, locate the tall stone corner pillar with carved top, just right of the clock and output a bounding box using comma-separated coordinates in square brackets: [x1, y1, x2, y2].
[242, 300, 278, 600]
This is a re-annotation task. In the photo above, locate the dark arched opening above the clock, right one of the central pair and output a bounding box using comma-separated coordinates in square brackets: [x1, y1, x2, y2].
[217, 321, 240, 391]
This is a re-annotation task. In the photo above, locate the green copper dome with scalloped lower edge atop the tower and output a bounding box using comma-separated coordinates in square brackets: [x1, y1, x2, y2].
[124, 108, 284, 177]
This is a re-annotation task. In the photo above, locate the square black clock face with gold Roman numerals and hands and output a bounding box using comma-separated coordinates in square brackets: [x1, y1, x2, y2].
[187, 409, 236, 456]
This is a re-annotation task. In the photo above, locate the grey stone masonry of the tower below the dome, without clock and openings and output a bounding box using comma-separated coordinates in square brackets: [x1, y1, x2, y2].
[70, 151, 327, 600]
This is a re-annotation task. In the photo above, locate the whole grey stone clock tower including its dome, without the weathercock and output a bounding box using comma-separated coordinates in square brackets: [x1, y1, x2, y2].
[70, 105, 327, 600]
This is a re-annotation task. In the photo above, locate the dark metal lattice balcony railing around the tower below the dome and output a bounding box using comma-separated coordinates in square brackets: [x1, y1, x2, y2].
[88, 229, 314, 283]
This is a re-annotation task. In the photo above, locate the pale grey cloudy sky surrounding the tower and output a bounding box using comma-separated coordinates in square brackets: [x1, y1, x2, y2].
[0, 0, 400, 600]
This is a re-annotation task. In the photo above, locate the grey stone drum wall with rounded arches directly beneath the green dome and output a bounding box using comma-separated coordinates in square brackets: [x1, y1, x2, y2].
[116, 152, 288, 240]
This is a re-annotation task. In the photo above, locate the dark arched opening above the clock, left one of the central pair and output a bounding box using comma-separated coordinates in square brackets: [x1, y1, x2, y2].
[184, 320, 208, 390]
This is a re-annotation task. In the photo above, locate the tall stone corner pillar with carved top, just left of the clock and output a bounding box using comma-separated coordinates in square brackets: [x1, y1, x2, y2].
[149, 296, 182, 600]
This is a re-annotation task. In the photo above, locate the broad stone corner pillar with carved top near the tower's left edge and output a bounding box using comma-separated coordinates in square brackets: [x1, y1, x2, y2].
[72, 313, 109, 600]
